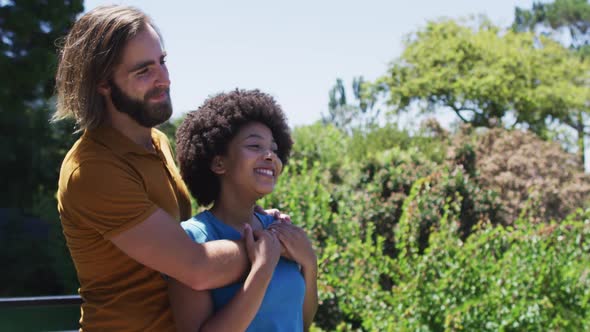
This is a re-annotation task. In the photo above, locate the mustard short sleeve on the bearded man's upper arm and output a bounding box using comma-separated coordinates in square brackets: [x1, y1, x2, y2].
[62, 161, 158, 239]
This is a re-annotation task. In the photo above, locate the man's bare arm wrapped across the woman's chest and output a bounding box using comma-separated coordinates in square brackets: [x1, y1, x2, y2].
[111, 209, 251, 290]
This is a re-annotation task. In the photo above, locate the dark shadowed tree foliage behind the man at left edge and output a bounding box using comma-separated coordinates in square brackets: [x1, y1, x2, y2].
[0, 0, 83, 296]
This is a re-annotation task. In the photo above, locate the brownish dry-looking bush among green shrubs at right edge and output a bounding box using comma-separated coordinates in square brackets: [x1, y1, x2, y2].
[474, 129, 590, 223]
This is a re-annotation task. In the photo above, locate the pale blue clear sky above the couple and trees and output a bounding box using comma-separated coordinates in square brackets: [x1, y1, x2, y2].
[84, 0, 533, 127]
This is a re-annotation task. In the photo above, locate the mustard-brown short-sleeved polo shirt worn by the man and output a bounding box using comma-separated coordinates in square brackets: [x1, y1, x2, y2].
[57, 125, 191, 331]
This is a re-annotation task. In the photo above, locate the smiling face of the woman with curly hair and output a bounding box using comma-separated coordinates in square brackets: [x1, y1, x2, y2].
[212, 122, 283, 199]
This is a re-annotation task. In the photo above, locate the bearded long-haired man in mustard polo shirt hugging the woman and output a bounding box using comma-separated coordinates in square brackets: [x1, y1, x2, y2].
[54, 6, 286, 331]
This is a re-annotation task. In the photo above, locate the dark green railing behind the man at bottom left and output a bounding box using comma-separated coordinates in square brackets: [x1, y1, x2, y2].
[0, 295, 82, 331]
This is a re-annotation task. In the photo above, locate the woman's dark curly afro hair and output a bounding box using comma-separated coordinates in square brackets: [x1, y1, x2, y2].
[176, 90, 293, 205]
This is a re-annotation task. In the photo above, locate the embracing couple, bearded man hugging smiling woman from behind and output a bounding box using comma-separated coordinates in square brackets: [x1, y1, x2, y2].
[54, 6, 317, 331]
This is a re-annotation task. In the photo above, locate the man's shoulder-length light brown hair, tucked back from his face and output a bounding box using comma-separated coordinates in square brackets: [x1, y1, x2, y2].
[52, 5, 159, 131]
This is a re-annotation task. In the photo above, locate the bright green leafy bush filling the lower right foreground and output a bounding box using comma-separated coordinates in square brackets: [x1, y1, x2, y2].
[316, 189, 590, 331]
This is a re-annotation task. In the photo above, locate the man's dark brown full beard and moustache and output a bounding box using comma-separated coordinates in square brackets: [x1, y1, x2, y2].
[110, 81, 172, 128]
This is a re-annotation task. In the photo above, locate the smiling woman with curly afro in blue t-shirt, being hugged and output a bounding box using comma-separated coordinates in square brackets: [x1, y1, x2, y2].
[169, 90, 317, 331]
